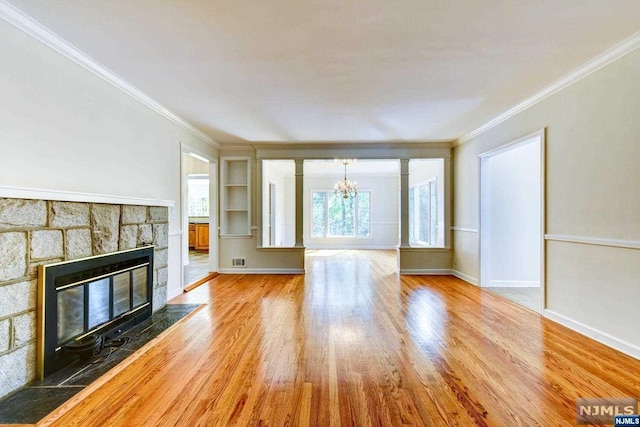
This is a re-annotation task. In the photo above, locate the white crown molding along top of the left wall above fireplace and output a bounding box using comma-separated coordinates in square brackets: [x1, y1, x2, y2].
[0, 0, 220, 149]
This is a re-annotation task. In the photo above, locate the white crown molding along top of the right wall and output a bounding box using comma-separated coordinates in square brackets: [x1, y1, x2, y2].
[454, 32, 640, 147]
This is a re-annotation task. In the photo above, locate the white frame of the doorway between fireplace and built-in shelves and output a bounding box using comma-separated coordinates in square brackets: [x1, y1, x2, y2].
[180, 143, 219, 289]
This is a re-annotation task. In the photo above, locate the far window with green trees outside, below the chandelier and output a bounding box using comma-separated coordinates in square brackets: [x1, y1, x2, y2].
[311, 191, 371, 237]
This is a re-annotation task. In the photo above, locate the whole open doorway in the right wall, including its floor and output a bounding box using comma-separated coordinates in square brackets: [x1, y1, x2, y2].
[480, 131, 544, 312]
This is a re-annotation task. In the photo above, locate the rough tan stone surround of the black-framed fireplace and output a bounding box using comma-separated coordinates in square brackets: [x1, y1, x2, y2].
[0, 198, 168, 397]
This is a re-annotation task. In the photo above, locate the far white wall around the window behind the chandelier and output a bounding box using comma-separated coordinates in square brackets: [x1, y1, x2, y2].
[304, 174, 400, 249]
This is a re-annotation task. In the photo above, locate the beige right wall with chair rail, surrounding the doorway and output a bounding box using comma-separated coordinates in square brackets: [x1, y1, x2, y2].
[454, 45, 640, 357]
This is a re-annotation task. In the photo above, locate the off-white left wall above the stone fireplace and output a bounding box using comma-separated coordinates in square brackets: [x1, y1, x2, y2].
[0, 20, 216, 302]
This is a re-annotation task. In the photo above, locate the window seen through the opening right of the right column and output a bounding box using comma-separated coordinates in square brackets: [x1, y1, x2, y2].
[409, 178, 438, 246]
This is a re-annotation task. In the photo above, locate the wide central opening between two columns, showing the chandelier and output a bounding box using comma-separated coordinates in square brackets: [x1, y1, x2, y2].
[302, 159, 400, 251]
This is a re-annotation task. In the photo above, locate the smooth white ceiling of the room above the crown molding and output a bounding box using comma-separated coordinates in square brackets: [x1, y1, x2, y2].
[5, 0, 640, 145]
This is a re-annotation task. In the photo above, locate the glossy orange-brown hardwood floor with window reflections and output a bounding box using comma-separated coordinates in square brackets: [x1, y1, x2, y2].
[43, 251, 640, 426]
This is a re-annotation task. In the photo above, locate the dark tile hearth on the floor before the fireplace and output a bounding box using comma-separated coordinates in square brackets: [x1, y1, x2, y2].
[0, 304, 199, 424]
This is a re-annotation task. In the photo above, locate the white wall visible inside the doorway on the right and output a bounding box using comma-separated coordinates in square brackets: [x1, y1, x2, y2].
[481, 137, 542, 287]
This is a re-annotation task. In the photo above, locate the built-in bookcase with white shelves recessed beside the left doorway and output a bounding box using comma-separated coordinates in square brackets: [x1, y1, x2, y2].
[220, 157, 251, 237]
